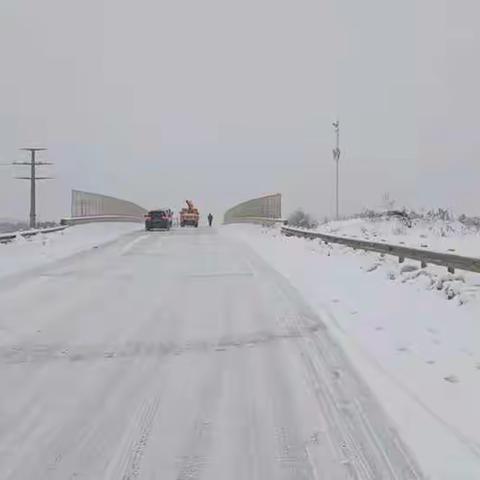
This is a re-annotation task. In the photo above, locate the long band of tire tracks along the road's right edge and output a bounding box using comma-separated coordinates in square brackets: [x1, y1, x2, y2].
[248, 248, 424, 480]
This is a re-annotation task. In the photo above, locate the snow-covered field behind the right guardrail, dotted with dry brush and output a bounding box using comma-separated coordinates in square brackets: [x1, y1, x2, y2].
[316, 217, 480, 257]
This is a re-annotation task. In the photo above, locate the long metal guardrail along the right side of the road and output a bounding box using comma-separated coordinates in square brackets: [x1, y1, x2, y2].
[282, 226, 480, 273]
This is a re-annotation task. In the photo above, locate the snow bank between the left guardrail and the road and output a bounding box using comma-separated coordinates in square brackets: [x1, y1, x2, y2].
[0, 223, 140, 277]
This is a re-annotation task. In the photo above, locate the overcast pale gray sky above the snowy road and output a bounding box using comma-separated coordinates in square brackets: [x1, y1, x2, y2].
[0, 0, 480, 219]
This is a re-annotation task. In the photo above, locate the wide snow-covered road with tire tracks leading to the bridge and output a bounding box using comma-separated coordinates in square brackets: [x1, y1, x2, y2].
[0, 228, 421, 480]
